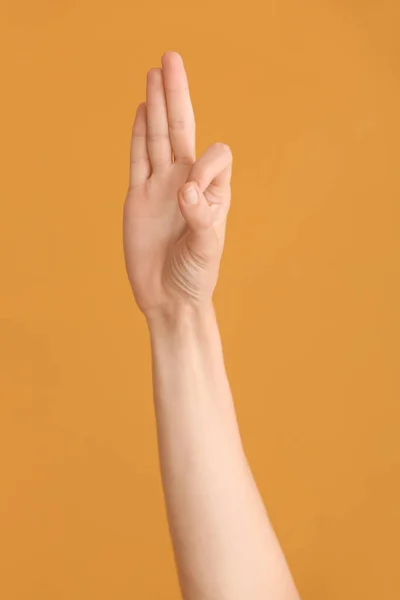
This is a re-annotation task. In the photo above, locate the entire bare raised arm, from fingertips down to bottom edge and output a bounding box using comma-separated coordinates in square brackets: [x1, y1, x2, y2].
[123, 52, 299, 600]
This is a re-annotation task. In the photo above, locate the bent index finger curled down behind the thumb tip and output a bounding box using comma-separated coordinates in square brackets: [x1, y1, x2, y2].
[187, 142, 233, 196]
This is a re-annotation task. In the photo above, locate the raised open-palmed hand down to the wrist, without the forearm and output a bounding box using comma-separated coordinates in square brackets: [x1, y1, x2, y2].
[123, 52, 232, 317]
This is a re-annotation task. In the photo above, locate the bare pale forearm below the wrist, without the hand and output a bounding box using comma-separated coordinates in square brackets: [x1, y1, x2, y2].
[148, 304, 298, 600]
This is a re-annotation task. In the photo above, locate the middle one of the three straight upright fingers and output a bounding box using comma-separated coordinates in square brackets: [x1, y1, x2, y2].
[146, 67, 172, 171]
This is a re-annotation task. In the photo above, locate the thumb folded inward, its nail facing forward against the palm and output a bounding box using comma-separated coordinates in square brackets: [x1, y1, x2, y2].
[178, 181, 218, 257]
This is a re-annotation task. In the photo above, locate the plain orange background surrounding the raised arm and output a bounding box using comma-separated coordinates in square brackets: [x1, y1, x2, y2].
[0, 0, 400, 600]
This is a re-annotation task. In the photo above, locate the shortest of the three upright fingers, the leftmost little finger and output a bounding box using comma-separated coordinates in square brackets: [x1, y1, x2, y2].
[129, 102, 151, 188]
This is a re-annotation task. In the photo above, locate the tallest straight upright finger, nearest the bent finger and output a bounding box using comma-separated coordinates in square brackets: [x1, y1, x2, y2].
[161, 52, 196, 163]
